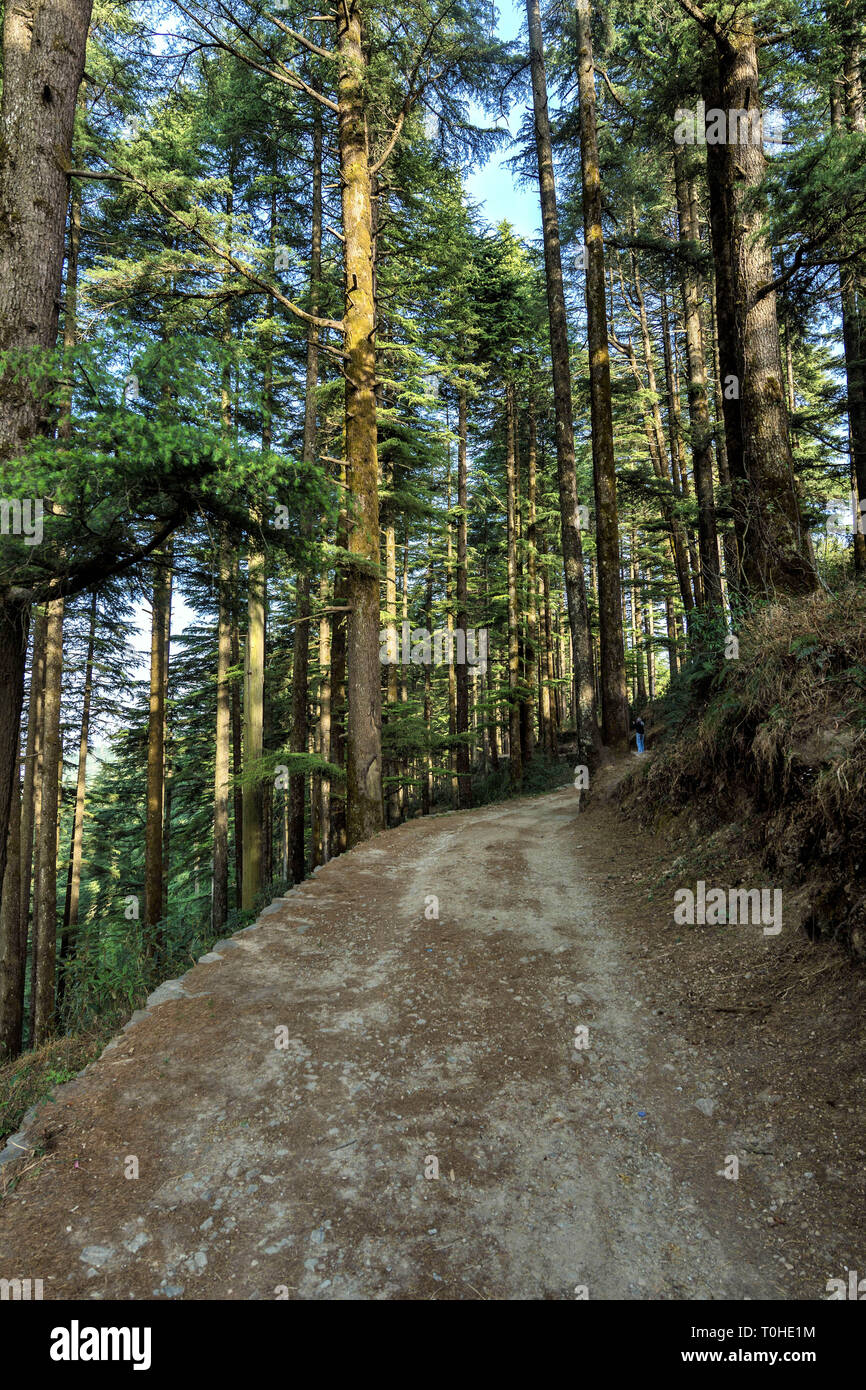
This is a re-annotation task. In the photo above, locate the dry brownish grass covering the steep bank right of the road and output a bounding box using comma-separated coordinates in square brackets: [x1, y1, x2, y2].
[621, 585, 866, 959]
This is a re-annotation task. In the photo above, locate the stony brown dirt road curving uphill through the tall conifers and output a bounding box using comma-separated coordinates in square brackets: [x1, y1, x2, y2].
[0, 762, 866, 1300]
